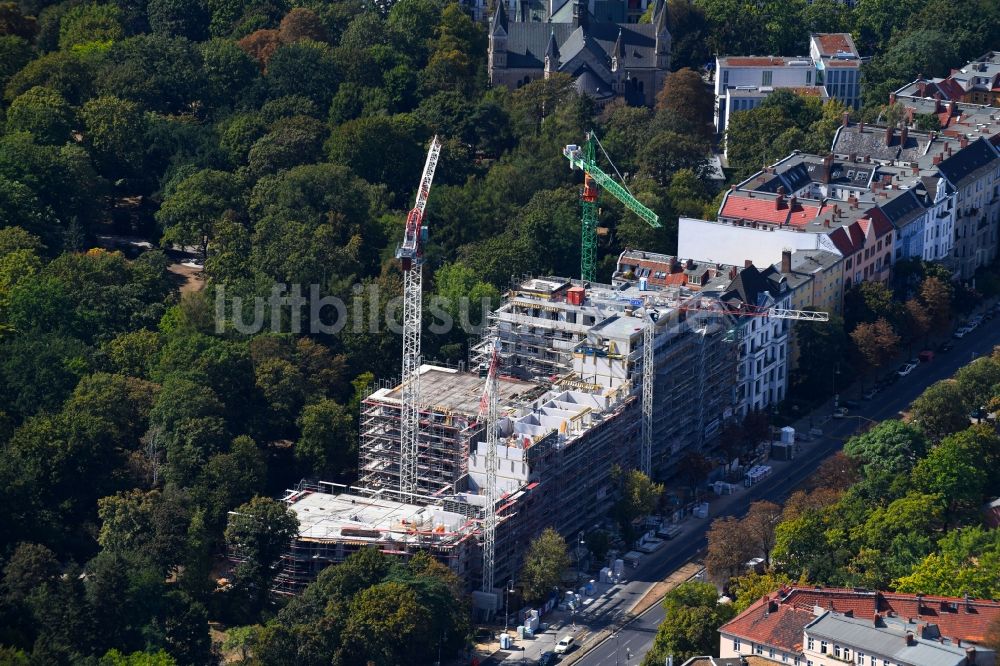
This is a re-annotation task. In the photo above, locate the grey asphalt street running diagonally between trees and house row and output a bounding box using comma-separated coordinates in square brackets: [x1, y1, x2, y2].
[574, 317, 1000, 666]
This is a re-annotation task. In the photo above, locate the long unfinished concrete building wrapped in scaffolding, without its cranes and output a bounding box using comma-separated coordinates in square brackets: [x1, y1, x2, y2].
[279, 258, 752, 591]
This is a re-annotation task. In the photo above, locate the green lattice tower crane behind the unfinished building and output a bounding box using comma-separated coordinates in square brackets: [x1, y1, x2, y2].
[563, 131, 660, 281]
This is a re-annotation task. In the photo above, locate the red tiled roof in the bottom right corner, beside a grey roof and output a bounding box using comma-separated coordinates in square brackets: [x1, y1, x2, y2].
[719, 588, 1000, 651]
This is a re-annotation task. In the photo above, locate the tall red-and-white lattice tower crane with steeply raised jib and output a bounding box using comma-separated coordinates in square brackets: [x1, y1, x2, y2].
[396, 136, 441, 496]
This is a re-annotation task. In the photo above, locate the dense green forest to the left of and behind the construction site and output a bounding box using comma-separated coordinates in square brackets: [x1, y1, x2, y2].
[0, 0, 1000, 664]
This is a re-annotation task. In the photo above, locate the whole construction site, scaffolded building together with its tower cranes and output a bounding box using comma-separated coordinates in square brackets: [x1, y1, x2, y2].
[266, 134, 828, 600]
